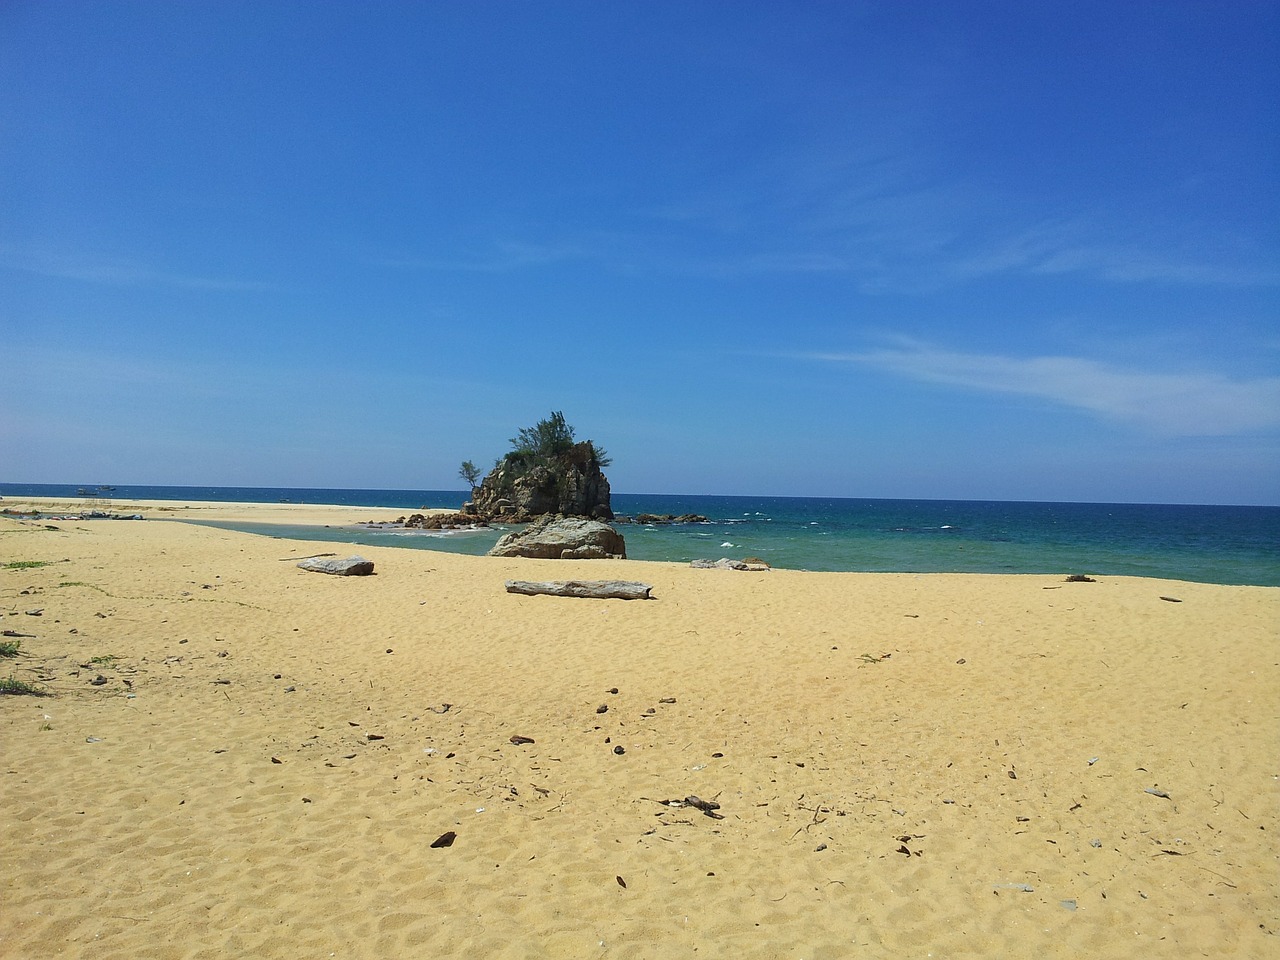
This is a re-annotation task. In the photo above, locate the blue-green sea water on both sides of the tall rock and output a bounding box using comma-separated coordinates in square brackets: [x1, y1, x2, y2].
[0, 484, 1280, 586]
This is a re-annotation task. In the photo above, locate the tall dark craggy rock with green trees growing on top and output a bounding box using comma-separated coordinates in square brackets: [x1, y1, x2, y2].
[462, 440, 613, 524]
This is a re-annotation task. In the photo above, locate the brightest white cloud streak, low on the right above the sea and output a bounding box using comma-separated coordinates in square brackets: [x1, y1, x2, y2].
[810, 346, 1280, 436]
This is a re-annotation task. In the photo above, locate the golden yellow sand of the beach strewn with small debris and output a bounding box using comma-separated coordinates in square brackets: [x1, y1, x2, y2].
[0, 502, 1280, 960]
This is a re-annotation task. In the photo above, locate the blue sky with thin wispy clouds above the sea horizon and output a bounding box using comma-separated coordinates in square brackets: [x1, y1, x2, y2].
[0, 0, 1280, 504]
